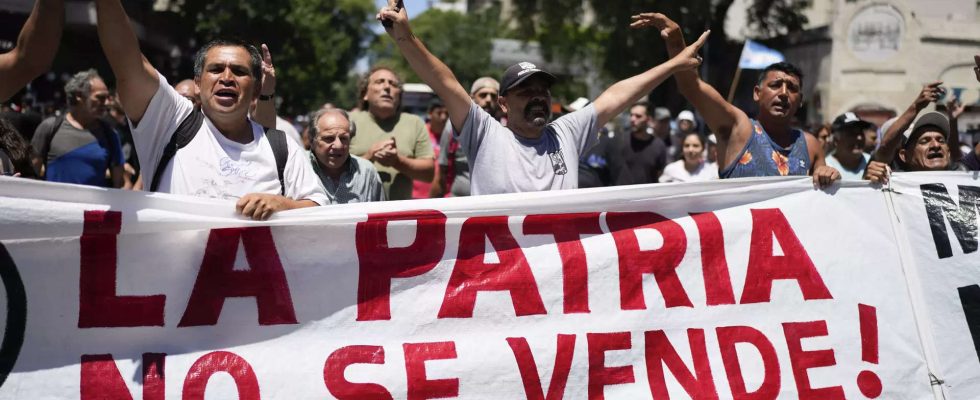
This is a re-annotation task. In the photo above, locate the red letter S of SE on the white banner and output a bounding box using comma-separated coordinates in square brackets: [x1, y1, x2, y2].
[323, 346, 392, 400]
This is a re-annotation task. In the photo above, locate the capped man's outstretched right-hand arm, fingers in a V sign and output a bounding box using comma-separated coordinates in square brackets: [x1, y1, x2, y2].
[593, 31, 711, 126]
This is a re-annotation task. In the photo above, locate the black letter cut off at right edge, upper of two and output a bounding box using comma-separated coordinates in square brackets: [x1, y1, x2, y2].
[920, 183, 980, 258]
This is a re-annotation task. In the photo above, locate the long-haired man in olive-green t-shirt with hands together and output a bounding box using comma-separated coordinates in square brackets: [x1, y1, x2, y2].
[350, 66, 435, 200]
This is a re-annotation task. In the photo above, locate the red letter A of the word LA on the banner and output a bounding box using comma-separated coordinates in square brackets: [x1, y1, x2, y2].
[177, 227, 297, 327]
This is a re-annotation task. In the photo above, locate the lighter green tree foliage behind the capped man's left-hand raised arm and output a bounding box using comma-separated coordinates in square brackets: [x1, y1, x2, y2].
[371, 8, 503, 88]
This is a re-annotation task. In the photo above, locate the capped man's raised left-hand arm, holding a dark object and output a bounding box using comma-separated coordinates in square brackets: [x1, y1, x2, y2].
[377, 0, 473, 131]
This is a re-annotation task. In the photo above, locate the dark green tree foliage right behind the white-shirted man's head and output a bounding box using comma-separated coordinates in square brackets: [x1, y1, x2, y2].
[180, 0, 376, 115]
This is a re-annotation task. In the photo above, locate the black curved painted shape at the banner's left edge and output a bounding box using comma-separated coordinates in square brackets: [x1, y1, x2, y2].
[0, 244, 27, 387]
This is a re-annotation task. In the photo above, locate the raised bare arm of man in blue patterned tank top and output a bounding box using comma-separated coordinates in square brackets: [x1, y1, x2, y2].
[630, 13, 751, 143]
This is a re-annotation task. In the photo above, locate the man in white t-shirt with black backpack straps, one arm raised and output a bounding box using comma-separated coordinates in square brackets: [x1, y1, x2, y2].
[95, 0, 327, 219]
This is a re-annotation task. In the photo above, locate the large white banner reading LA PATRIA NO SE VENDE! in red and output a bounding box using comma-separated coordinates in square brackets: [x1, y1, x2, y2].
[0, 178, 933, 400]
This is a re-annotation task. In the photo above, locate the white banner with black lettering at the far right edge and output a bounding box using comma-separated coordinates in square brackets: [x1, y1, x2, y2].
[892, 173, 980, 399]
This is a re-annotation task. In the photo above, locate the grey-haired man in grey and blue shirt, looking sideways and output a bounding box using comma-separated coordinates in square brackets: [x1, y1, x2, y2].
[31, 69, 126, 188]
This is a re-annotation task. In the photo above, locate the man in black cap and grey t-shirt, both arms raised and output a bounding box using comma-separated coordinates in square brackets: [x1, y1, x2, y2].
[377, 0, 707, 195]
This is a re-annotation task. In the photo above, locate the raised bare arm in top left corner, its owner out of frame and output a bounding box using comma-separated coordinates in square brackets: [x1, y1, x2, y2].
[0, 0, 65, 101]
